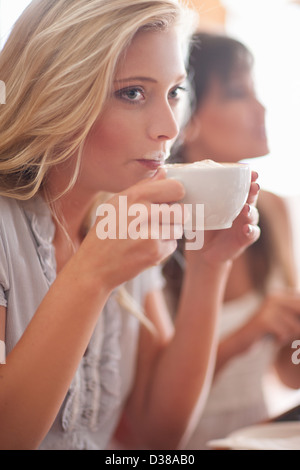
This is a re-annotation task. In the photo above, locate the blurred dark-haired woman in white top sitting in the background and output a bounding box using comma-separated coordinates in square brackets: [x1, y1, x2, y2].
[164, 33, 300, 449]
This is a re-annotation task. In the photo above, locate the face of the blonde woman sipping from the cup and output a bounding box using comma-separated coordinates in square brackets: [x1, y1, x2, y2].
[79, 30, 186, 192]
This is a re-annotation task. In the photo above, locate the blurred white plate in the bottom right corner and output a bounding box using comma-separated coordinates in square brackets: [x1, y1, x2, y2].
[207, 421, 300, 450]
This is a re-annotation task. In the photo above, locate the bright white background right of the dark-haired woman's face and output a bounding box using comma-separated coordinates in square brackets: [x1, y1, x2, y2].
[222, 0, 300, 196]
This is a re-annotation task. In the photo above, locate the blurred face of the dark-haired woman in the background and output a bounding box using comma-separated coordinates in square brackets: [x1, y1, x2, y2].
[186, 72, 269, 162]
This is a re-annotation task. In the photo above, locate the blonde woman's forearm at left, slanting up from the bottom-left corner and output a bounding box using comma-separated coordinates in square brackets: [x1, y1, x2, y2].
[0, 258, 110, 450]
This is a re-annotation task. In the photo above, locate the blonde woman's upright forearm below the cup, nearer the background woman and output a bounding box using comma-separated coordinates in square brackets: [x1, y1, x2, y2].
[132, 263, 230, 449]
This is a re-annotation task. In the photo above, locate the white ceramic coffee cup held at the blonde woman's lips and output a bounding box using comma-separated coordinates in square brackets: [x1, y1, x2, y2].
[164, 160, 251, 230]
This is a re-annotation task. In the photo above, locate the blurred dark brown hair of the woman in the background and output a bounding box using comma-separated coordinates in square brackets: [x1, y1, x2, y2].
[164, 33, 284, 312]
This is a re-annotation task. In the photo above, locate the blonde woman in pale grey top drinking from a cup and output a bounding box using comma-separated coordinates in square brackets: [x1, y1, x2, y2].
[0, 0, 259, 450]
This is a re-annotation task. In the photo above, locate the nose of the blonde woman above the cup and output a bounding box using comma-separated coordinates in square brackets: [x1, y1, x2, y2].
[148, 101, 179, 141]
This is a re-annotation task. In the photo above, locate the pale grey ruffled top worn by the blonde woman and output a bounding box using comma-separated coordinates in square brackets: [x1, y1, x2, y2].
[0, 197, 163, 450]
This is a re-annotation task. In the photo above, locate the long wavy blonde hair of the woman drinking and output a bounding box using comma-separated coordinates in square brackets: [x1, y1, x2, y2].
[0, 0, 196, 199]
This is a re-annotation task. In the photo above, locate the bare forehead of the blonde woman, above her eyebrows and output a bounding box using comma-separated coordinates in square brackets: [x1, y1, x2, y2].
[116, 28, 185, 80]
